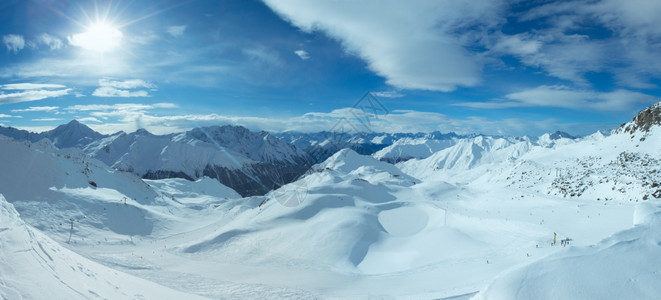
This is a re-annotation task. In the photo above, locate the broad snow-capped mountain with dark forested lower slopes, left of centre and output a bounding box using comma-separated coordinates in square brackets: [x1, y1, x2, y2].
[84, 126, 310, 196]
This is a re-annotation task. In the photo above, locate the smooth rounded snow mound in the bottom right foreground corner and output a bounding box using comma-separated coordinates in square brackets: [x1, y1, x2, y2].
[473, 206, 661, 300]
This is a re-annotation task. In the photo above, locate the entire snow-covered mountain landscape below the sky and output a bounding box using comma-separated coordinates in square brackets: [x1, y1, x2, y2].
[0, 103, 661, 300]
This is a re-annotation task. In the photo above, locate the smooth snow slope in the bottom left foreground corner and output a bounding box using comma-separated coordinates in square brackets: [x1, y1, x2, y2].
[0, 194, 203, 299]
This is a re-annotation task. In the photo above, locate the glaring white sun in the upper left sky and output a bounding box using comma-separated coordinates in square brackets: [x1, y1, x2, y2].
[69, 21, 123, 53]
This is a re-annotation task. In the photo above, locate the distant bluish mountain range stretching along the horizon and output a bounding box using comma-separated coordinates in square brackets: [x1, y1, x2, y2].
[0, 120, 573, 196]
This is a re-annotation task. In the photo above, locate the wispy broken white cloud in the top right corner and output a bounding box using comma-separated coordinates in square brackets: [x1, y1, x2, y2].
[485, 0, 661, 89]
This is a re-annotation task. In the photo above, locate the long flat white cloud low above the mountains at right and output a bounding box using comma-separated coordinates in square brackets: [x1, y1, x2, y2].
[456, 85, 659, 111]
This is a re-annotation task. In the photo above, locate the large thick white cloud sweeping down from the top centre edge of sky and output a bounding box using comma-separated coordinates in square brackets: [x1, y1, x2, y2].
[264, 0, 500, 92]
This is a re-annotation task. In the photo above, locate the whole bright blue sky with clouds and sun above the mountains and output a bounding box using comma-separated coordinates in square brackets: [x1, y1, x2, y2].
[0, 0, 661, 135]
